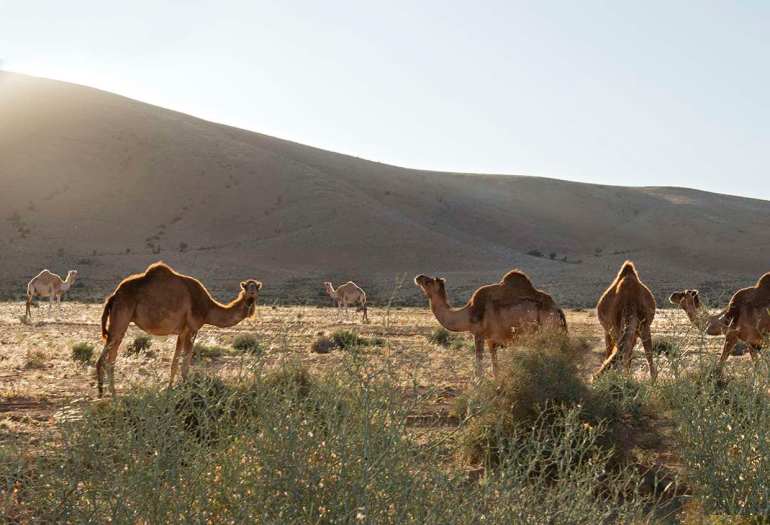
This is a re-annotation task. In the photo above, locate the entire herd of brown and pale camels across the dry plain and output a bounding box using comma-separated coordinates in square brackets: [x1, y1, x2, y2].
[26, 261, 770, 397]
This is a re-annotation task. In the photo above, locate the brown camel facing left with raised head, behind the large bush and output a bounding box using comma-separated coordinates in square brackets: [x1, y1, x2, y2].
[414, 270, 567, 378]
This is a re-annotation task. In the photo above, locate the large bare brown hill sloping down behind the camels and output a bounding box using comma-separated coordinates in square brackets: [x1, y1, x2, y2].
[0, 73, 770, 305]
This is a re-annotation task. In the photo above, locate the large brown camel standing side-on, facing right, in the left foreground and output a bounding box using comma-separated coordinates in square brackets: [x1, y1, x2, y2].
[96, 262, 262, 397]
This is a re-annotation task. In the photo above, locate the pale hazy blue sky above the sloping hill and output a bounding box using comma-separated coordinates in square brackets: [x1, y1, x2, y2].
[0, 0, 770, 199]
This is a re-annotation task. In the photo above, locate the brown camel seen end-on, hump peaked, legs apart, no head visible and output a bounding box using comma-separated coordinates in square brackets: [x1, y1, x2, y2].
[594, 261, 658, 381]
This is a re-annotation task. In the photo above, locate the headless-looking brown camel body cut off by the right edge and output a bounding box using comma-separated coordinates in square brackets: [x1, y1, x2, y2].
[717, 273, 770, 373]
